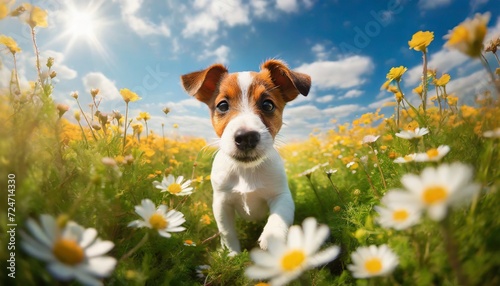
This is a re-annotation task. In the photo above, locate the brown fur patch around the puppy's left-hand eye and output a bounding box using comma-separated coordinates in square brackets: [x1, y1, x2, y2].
[209, 74, 242, 137]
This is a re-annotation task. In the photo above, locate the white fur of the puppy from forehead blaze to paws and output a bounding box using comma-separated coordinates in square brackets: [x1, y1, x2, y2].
[211, 72, 295, 254]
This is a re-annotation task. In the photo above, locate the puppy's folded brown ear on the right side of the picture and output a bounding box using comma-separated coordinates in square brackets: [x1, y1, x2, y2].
[262, 60, 311, 102]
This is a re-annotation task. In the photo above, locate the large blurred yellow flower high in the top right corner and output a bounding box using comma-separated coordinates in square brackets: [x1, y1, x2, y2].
[445, 13, 490, 57]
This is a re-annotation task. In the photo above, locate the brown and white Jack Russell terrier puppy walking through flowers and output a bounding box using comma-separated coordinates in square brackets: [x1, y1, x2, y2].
[181, 60, 311, 255]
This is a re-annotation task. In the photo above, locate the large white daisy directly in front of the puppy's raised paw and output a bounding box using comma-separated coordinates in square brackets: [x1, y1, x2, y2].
[245, 217, 340, 285]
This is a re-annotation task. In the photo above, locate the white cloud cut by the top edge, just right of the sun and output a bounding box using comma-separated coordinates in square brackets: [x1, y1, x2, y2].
[114, 0, 171, 37]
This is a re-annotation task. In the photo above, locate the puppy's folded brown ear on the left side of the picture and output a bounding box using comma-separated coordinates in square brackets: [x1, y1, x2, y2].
[181, 64, 227, 104]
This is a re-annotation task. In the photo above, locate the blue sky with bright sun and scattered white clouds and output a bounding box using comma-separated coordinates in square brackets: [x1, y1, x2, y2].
[0, 0, 500, 141]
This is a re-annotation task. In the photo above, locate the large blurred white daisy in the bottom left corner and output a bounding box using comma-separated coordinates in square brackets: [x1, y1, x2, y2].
[21, 214, 116, 285]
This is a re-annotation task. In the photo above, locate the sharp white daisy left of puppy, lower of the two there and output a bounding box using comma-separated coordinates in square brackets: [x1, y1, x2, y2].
[128, 199, 186, 238]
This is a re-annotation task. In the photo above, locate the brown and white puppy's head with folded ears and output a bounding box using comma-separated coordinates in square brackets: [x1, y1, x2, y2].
[181, 60, 311, 165]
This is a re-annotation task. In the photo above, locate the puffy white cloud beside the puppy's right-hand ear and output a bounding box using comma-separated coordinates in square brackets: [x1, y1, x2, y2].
[296, 56, 374, 89]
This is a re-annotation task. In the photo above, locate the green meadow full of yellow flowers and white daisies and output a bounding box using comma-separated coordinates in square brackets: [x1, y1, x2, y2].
[0, 5, 500, 285]
